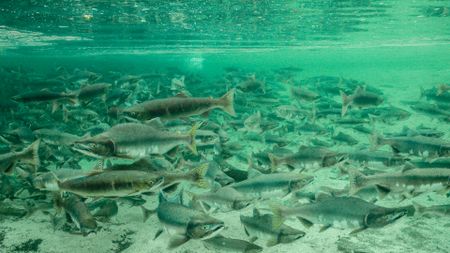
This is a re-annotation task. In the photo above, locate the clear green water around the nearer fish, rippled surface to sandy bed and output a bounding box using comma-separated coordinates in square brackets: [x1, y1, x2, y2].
[0, 0, 450, 253]
